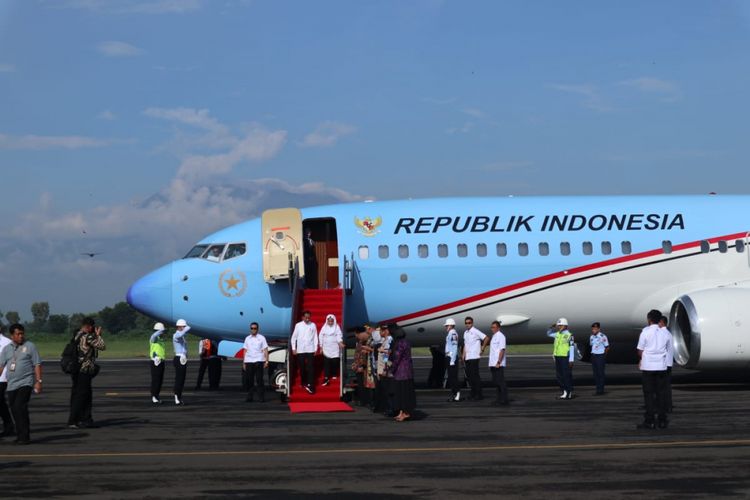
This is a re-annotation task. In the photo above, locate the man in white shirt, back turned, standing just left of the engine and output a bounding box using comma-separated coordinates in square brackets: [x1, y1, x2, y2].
[636, 309, 671, 429]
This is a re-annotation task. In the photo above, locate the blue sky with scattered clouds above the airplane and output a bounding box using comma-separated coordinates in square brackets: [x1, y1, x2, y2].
[0, 0, 750, 319]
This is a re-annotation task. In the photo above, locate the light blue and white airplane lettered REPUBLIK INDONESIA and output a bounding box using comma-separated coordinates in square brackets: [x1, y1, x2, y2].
[127, 195, 750, 369]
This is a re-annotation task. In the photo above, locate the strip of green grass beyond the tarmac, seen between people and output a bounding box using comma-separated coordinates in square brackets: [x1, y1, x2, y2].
[26, 333, 552, 361]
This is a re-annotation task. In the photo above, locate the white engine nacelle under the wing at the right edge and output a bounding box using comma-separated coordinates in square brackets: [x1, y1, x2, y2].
[669, 288, 750, 370]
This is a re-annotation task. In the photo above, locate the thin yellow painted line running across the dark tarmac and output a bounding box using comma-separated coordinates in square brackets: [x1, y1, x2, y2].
[0, 439, 750, 459]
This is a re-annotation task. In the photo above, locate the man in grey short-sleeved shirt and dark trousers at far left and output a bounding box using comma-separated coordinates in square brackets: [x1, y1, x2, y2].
[0, 323, 42, 444]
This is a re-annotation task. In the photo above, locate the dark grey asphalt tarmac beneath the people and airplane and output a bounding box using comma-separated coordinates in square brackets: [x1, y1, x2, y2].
[0, 356, 750, 499]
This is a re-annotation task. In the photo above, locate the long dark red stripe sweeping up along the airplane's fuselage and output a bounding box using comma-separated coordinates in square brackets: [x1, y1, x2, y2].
[386, 232, 750, 323]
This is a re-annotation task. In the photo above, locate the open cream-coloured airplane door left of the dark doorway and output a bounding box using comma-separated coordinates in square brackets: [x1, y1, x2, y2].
[261, 208, 305, 283]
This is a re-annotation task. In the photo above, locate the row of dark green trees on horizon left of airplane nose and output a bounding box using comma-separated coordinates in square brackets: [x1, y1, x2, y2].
[0, 302, 154, 335]
